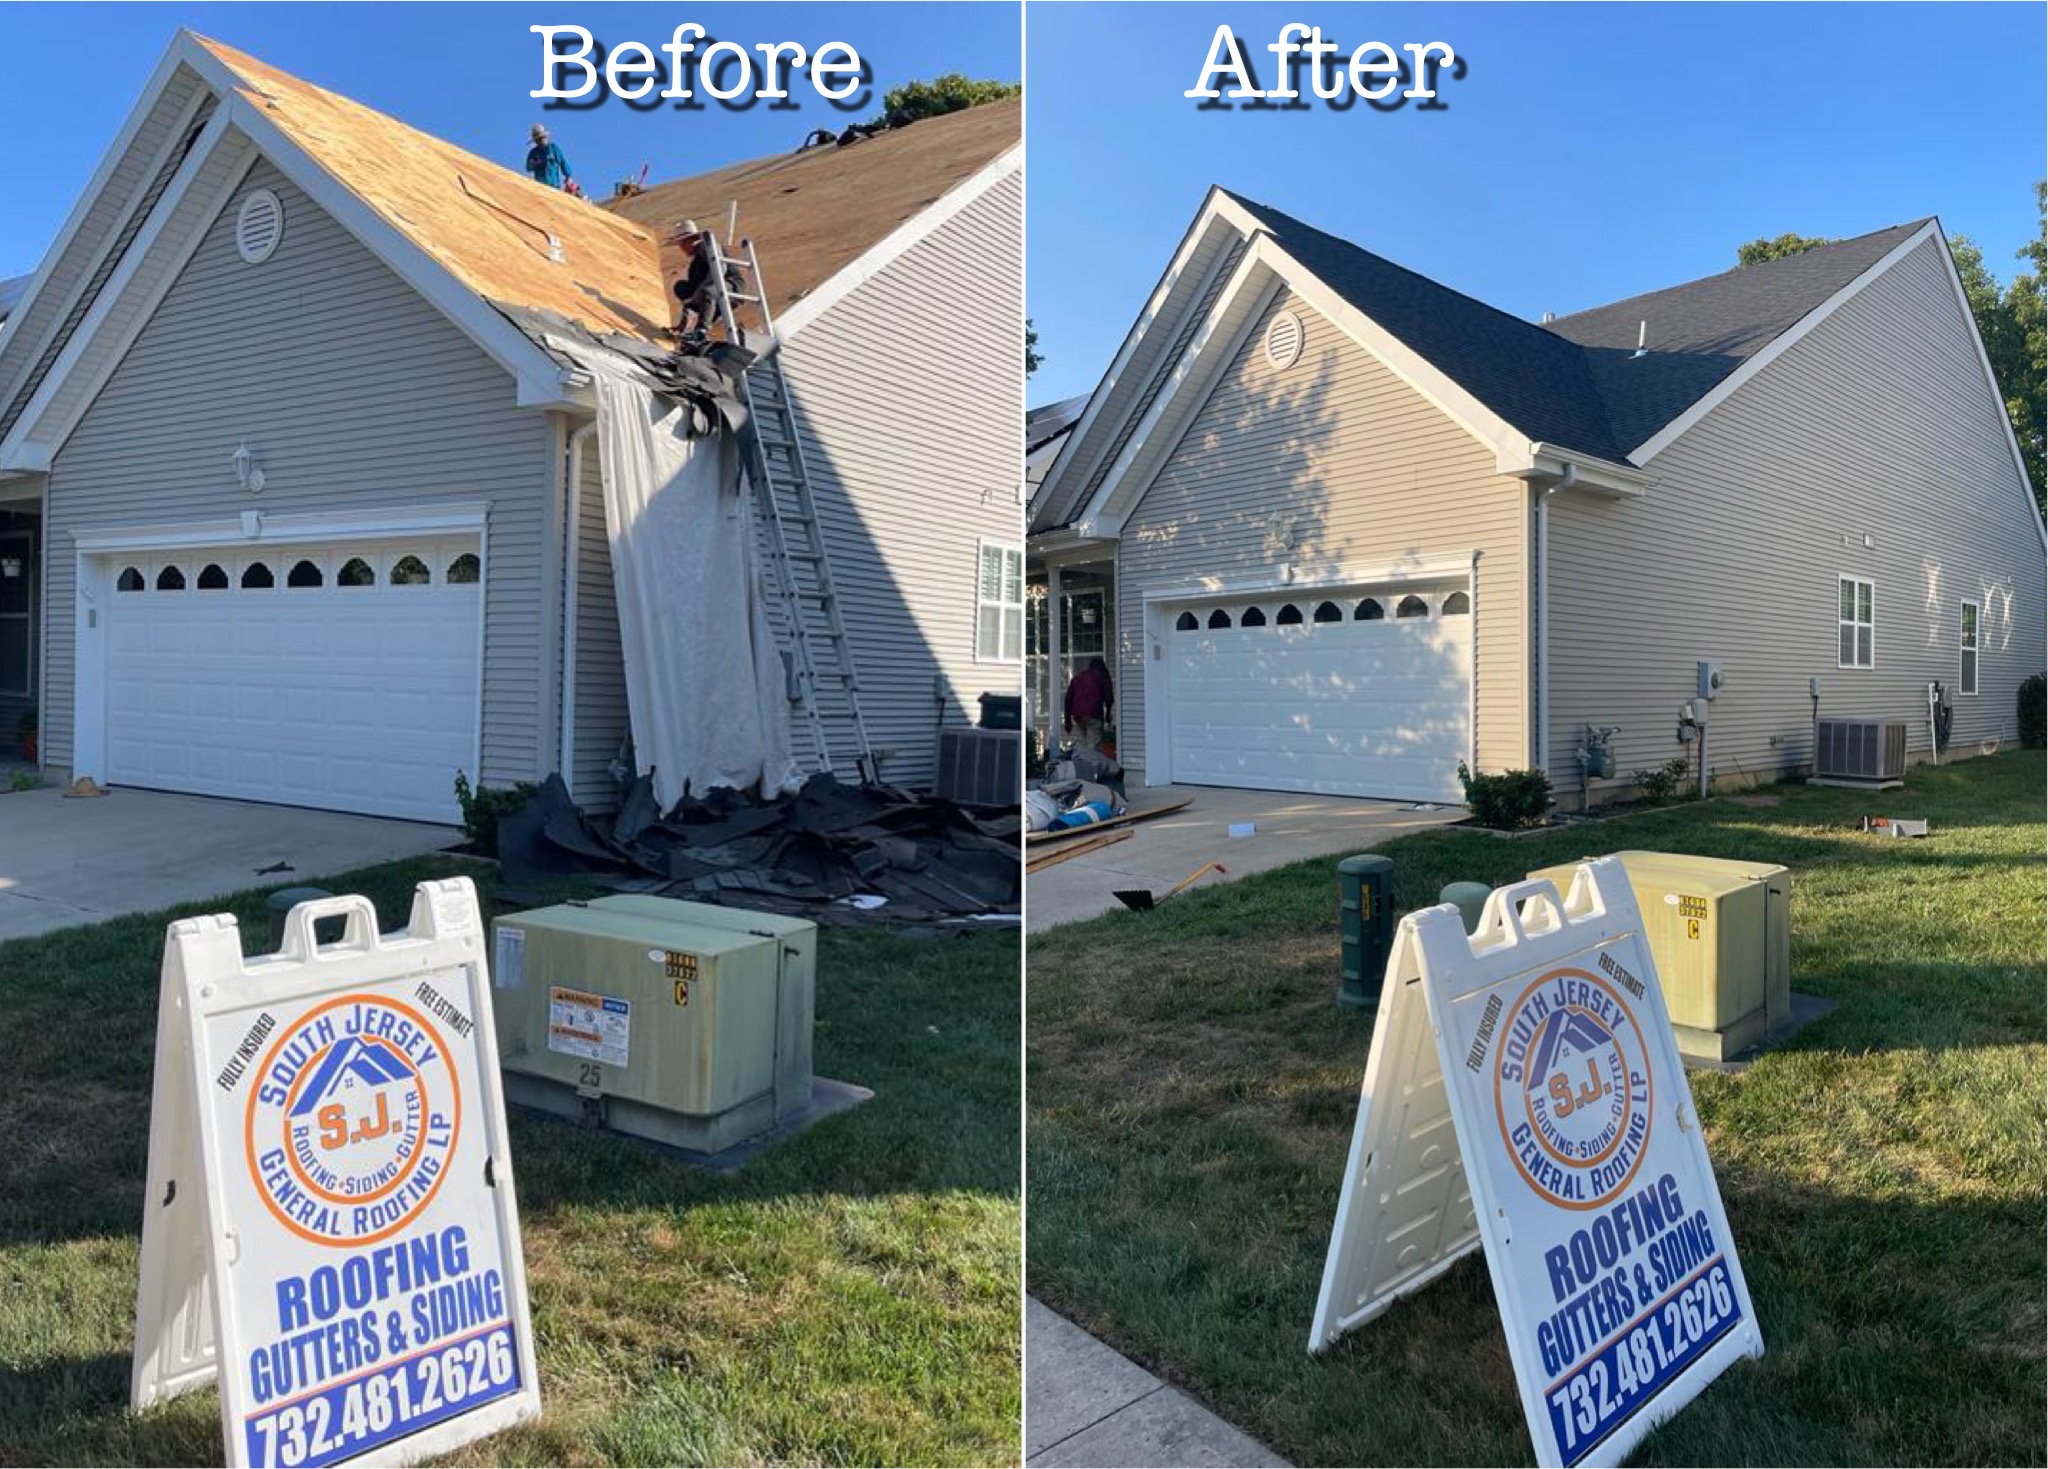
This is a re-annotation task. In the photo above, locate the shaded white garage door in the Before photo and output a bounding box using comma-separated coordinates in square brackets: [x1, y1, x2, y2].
[104, 537, 483, 822]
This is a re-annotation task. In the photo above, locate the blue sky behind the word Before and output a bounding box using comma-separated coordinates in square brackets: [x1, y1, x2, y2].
[0, 2, 1022, 279]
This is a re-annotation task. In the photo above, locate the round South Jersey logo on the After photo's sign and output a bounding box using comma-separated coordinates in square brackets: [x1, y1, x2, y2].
[1493, 969, 1651, 1209]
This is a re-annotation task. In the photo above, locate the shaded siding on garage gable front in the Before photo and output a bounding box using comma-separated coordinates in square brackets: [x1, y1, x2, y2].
[45, 162, 555, 785]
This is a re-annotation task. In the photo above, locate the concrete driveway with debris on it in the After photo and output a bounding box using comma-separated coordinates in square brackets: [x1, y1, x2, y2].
[1024, 785, 1464, 932]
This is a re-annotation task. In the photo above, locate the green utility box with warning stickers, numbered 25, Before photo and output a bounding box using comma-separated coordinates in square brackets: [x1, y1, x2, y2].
[492, 895, 817, 1153]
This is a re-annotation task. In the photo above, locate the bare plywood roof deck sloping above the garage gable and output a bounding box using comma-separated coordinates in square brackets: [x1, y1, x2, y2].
[199, 37, 674, 340]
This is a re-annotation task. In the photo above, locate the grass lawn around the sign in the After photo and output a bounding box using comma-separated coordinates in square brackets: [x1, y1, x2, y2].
[1026, 750, 2048, 1465]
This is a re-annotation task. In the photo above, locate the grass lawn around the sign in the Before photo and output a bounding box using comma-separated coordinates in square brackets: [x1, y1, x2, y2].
[0, 858, 1022, 1465]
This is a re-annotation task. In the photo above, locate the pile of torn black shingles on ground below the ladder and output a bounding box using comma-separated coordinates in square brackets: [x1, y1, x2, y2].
[498, 774, 1022, 924]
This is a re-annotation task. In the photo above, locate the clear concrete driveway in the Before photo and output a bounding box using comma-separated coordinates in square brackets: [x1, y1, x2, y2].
[0, 787, 463, 940]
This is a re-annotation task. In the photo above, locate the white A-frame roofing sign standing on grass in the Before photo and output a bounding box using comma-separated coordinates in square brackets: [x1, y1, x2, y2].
[131, 877, 541, 1469]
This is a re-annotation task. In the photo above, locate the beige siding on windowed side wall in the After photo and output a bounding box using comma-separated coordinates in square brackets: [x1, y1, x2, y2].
[1550, 240, 2044, 799]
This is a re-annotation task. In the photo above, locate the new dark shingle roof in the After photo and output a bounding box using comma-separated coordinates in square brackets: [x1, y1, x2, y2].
[1225, 191, 1927, 463]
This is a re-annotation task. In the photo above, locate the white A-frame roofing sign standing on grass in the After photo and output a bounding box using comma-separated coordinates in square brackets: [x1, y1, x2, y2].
[1309, 858, 1763, 1465]
